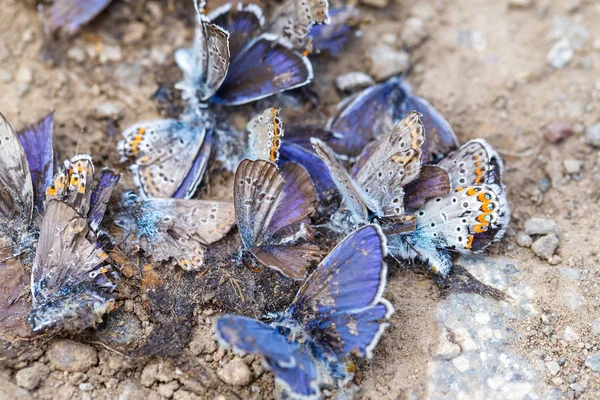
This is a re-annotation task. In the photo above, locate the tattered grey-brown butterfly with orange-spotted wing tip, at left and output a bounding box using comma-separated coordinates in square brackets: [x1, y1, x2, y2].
[29, 155, 120, 332]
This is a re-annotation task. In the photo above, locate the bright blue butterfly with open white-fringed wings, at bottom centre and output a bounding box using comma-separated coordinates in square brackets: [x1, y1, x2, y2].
[216, 225, 394, 398]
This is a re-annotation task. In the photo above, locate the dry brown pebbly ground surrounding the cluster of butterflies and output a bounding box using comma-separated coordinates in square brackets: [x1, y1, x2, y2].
[0, 0, 600, 400]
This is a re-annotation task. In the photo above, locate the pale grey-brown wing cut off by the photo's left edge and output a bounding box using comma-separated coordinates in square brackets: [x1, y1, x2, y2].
[0, 114, 34, 234]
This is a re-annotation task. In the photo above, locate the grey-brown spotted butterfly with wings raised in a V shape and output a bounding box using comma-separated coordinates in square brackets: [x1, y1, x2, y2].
[311, 111, 425, 224]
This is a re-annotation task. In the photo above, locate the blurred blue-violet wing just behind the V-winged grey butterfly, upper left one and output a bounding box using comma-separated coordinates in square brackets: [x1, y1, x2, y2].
[326, 78, 406, 158]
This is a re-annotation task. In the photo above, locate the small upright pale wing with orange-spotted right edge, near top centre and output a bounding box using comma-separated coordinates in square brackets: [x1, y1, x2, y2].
[246, 107, 284, 163]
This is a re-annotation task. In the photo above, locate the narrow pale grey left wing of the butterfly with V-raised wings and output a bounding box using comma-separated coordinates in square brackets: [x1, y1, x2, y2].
[311, 138, 379, 222]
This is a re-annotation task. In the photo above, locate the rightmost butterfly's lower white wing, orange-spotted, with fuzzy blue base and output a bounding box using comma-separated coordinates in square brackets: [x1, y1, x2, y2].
[401, 185, 510, 276]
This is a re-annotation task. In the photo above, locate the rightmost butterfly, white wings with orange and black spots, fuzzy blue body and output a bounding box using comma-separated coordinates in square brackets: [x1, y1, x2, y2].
[388, 139, 510, 276]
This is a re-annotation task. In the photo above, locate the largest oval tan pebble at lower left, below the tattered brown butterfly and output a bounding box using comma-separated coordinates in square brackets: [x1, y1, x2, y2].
[46, 340, 98, 372]
